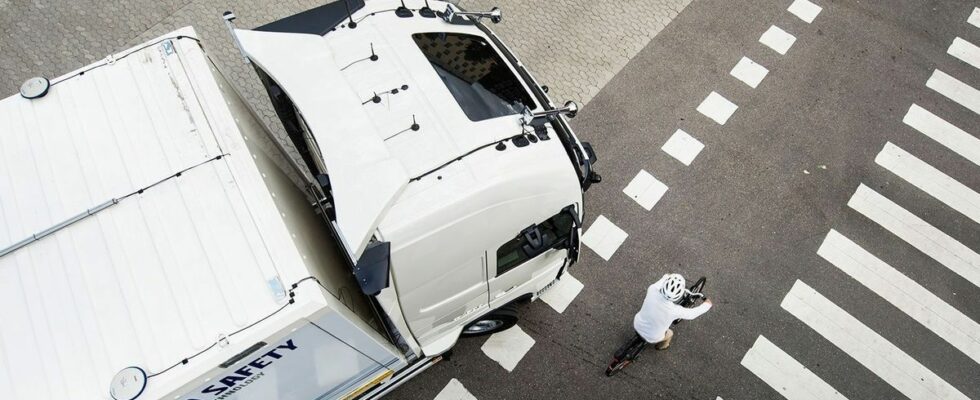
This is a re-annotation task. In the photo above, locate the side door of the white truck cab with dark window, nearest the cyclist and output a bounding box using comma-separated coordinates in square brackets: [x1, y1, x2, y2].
[487, 209, 575, 308]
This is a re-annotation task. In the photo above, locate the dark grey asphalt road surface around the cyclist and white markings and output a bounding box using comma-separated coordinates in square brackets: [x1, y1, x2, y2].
[392, 0, 980, 399]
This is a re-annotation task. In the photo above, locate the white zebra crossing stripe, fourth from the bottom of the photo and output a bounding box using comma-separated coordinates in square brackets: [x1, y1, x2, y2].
[847, 184, 980, 287]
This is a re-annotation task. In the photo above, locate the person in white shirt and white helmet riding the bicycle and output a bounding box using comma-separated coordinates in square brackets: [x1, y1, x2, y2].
[631, 274, 711, 350]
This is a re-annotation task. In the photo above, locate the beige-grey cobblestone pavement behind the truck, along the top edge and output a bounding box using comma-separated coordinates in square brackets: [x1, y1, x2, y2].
[0, 0, 690, 177]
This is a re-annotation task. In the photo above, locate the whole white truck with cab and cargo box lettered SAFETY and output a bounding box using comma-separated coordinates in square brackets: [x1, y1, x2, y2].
[0, 0, 600, 400]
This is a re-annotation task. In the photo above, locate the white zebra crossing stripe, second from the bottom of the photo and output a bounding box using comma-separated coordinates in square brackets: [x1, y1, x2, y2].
[780, 280, 968, 400]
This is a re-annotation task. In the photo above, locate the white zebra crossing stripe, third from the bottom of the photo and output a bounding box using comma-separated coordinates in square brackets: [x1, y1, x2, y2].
[817, 230, 980, 363]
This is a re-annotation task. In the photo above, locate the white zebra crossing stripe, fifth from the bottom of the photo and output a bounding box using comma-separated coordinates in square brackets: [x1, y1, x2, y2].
[875, 142, 980, 223]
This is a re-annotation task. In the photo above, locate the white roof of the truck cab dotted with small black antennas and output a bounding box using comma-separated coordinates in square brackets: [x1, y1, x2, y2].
[236, 0, 571, 259]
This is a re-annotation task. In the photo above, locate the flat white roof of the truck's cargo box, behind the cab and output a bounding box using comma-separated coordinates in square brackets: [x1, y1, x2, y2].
[0, 27, 320, 399]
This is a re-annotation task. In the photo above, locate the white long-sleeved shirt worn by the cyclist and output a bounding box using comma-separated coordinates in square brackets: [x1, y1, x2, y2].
[633, 275, 711, 343]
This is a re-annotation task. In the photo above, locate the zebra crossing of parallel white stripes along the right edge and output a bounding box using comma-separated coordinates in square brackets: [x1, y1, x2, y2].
[741, 8, 980, 399]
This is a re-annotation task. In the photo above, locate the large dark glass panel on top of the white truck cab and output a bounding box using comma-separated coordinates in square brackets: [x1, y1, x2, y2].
[412, 32, 535, 121]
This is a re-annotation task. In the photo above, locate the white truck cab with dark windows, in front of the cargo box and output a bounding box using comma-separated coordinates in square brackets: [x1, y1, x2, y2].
[233, 0, 598, 355]
